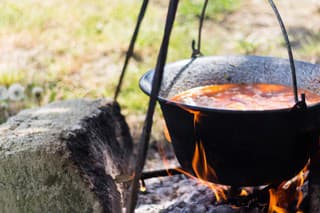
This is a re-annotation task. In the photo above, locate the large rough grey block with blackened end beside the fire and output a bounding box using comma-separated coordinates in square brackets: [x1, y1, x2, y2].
[0, 100, 132, 212]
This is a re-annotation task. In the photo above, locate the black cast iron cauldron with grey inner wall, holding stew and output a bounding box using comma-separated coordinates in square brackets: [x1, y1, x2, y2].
[140, 56, 320, 186]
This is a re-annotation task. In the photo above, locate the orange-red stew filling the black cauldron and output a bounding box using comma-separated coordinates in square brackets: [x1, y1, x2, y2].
[171, 84, 320, 110]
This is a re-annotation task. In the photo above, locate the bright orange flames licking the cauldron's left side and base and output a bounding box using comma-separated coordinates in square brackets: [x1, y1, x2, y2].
[161, 103, 309, 210]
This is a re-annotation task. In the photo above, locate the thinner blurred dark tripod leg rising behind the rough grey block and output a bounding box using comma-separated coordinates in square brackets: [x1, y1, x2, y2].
[113, 0, 149, 101]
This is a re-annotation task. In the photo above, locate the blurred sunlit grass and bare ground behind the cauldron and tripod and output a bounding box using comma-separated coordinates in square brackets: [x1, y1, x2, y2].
[0, 0, 320, 140]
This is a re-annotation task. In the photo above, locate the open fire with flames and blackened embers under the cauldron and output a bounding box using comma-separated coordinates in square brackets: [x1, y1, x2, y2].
[150, 134, 309, 213]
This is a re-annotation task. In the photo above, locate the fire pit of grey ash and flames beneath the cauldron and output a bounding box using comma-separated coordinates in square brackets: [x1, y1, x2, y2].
[135, 142, 312, 213]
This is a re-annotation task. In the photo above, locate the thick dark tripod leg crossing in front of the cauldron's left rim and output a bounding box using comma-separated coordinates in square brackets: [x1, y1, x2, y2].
[126, 0, 179, 213]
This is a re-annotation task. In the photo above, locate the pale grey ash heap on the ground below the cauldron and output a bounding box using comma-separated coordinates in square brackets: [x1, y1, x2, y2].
[136, 175, 267, 213]
